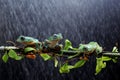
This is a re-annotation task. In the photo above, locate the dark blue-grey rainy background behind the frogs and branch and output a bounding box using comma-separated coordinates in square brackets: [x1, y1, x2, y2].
[0, 0, 120, 80]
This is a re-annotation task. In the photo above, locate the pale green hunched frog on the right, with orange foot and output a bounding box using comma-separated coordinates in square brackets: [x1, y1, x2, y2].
[69, 41, 103, 60]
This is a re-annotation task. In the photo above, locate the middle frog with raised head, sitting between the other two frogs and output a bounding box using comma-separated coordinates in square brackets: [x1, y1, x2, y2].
[44, 33, 63, 49]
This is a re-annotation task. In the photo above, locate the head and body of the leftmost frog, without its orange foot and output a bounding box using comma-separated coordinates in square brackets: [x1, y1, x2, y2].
[16, 35, 42, 50]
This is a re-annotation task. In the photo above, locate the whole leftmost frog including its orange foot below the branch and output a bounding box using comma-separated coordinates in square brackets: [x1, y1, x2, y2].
[16, 35, 42, 59]
